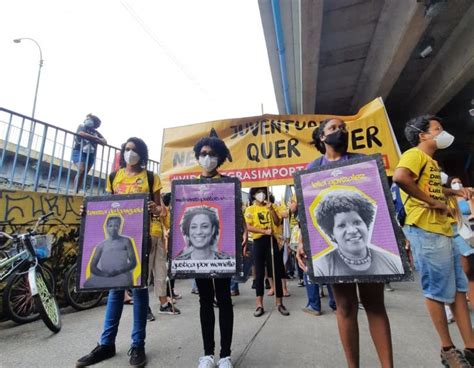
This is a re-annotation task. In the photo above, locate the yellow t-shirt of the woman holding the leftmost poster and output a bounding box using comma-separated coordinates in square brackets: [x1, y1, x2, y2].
[105, 169, 163, 237]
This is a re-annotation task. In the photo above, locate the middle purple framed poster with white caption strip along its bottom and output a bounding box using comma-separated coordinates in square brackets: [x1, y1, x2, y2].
[168, 177, 242, 278]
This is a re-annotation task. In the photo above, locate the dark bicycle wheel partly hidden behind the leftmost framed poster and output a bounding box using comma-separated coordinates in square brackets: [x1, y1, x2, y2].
[63, 265, 106, 310]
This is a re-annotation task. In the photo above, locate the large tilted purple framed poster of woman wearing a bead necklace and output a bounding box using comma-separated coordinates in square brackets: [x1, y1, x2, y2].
[294, 155, 411, 283]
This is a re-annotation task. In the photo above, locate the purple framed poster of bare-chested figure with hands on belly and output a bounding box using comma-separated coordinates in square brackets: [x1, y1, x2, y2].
[76, 194, 149, 291]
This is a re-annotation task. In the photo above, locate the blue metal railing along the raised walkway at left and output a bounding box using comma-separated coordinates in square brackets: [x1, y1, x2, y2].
[0, 107, 159, 195]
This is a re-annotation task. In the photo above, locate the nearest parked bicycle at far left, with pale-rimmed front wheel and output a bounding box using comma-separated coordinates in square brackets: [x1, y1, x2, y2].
[0, 212, 61, 333]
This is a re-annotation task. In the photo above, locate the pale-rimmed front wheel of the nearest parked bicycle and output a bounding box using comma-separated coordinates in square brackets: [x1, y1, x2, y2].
[33, 268, 61, 333]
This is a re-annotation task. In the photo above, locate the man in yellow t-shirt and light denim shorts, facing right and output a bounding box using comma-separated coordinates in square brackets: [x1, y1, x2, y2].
[393, 115, 474, 367]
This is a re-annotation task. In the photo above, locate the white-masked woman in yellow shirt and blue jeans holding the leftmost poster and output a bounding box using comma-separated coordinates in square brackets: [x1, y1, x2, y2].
[76, 137, 162, 367]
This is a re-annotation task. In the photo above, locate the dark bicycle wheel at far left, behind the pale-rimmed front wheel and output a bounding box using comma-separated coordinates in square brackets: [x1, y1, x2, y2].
[2, 266, 54, 324]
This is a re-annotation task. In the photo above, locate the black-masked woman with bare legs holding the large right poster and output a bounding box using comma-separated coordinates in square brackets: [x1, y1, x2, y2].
[297, 118, 393, 367]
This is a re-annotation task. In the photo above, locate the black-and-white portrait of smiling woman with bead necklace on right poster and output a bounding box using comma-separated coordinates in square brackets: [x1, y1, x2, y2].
[313, 189, 403, 276]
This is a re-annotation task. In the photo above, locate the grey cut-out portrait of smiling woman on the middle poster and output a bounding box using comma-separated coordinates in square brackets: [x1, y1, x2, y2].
[176, 206, 231, 260]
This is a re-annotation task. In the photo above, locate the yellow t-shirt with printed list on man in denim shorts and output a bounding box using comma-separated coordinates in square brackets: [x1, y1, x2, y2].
[397, 147, 453, 236]
